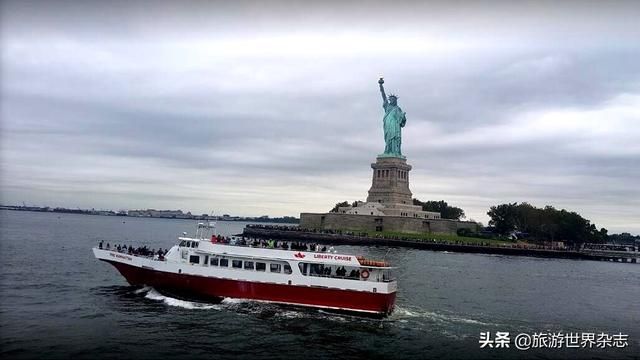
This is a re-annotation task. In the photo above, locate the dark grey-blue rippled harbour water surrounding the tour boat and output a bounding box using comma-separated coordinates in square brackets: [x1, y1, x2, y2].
[0, 211, 640, 359]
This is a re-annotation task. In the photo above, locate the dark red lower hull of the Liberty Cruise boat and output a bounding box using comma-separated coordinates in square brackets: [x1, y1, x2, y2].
[108, 261, 396, 315]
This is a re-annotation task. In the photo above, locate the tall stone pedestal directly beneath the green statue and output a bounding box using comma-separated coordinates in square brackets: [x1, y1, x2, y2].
[367, 157, 413, 205]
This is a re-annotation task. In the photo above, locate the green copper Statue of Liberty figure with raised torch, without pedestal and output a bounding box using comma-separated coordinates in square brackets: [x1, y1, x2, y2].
[378, 78, 407, 159]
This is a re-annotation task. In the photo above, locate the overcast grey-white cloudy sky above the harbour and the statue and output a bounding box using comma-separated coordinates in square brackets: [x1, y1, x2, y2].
[0, 1, 640, 234]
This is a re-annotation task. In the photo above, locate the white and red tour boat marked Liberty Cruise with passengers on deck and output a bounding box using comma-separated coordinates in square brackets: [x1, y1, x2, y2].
[93, 223, 397, 317]
